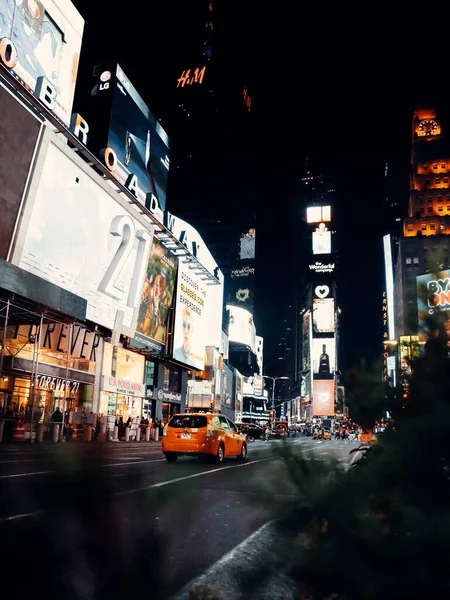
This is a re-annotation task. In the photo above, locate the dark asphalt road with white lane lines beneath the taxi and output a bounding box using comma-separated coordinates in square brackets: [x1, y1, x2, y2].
[0, 437, 358, 598]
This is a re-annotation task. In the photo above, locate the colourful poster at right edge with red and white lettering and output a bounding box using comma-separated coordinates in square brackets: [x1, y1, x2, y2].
[416, 271, 450, 343]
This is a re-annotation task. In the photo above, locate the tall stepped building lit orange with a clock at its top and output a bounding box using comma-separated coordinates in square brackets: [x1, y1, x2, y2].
[395, 107, 450, 337]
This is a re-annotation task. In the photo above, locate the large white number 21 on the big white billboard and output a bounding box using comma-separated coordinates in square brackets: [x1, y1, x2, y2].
[98, 215, 152, 308]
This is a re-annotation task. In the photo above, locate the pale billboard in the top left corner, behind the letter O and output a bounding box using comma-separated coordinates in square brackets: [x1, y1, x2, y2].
[0, 0, 84, 125]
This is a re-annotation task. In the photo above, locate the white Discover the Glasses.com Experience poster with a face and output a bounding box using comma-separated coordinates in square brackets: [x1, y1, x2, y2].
[172, 261, 208, 371]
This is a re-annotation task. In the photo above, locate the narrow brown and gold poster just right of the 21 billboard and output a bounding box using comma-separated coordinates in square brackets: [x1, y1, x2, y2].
[131, 238, 178, 354]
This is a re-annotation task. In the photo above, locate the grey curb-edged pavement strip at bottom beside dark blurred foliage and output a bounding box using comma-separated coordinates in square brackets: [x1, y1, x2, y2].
[170, 521, 299, 600]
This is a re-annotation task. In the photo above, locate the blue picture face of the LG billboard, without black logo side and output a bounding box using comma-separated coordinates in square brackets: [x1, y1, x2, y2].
[106, 65, 170, 222]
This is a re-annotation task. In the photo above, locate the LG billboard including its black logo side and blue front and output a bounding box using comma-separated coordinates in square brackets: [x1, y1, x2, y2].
[76, 63, 170, 223]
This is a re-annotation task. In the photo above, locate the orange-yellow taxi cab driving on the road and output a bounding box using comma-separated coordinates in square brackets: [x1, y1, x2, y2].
[161, 413, 247, 463]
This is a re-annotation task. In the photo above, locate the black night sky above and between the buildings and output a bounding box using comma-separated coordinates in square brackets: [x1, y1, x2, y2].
[70, 0, 449, 375]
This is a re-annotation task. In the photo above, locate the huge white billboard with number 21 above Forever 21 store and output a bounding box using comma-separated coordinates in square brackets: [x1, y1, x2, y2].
[12, 130, 153, 337]
